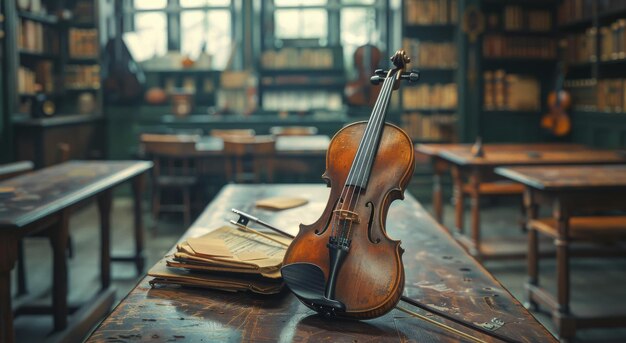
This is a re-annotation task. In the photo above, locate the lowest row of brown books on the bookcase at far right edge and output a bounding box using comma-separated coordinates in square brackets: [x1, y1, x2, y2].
[564, 79, 626, 113]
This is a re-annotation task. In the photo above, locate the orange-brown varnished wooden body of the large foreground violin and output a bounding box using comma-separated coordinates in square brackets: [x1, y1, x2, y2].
[284, 122, 415, 319]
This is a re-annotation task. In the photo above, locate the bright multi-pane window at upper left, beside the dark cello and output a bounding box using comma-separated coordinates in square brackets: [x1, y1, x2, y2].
[124, 0, 233, 69]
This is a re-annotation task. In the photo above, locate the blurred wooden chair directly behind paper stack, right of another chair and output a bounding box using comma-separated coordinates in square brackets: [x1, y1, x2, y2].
[224, 136, 276, 182]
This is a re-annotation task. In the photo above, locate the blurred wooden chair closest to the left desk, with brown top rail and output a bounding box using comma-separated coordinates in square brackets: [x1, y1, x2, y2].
[141, 134, 200, 226]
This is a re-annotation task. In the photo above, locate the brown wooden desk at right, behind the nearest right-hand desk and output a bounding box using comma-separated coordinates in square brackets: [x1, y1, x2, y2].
[439, 149, 626, 259]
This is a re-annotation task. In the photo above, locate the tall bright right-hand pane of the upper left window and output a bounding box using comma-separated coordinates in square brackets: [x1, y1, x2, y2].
[181, 10, 231, 69]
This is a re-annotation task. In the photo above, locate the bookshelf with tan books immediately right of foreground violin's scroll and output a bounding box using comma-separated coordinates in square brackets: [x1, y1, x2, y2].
[400, 0, 459, 143]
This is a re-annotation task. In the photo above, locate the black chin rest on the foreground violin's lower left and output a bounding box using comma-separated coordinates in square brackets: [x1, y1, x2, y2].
[280, 262, 346, 317]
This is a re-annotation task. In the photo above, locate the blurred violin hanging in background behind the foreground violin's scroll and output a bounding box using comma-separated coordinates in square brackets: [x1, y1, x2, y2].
[344, 44, 382, 106]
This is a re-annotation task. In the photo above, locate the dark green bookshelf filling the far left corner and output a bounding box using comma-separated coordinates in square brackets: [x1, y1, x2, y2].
[1, 0, 111, 168]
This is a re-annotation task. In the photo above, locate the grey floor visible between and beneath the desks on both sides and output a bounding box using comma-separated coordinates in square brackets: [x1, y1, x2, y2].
[8, 197, 626, 342]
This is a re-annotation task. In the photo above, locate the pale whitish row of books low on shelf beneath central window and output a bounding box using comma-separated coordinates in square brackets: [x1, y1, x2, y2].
[263, 91, 343, 112]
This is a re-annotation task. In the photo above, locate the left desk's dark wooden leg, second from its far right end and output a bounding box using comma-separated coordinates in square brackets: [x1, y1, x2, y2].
[98, 189, 112, 290]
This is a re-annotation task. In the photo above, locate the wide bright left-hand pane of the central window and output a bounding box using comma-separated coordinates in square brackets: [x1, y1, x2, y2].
[274, 9, 328, 39]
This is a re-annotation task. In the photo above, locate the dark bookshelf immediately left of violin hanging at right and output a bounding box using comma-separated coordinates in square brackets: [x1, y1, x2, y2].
[472, 0, 558, 142]
